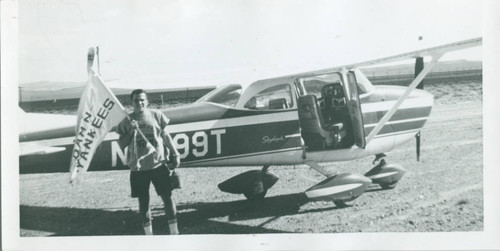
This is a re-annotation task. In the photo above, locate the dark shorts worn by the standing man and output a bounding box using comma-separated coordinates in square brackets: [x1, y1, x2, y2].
[130, 165, 172, 198]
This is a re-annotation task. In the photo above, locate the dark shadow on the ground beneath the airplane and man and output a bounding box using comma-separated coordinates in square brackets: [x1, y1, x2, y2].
[20, 193, 336, 236]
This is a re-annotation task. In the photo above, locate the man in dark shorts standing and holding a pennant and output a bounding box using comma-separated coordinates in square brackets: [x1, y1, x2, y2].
[116, 89, 180, 235]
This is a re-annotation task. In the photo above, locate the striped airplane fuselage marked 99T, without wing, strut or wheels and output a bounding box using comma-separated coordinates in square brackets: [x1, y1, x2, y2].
[19, 72, 433, 173]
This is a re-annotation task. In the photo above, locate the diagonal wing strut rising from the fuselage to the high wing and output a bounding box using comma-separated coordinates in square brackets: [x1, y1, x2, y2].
[366, 53, 443, 145]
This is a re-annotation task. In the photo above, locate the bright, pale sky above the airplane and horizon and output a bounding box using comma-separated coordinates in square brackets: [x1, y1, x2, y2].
[18, 0, 482, 88]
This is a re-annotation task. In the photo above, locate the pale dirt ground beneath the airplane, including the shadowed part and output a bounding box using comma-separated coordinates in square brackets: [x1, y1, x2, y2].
[19, 81, 484, 236]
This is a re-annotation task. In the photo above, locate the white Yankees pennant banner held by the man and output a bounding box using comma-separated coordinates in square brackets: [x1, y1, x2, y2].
[69, 70, 127, 182]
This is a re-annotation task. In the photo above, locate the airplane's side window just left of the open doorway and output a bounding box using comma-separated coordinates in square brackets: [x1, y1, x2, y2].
[243, 84, 293, 110]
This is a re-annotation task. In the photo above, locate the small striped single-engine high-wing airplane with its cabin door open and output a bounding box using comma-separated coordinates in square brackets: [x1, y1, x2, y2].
[19, 38, 482, 207]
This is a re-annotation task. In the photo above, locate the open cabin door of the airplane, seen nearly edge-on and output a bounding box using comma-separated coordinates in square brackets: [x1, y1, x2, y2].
[346, 71, 366, 149]
